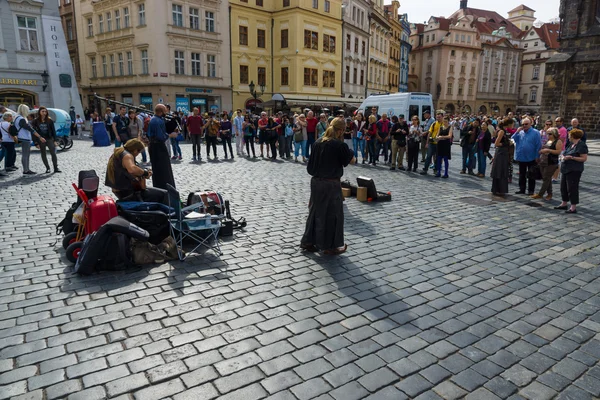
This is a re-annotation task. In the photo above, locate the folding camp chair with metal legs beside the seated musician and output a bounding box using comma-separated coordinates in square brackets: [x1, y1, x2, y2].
[167, 184, 223, 261]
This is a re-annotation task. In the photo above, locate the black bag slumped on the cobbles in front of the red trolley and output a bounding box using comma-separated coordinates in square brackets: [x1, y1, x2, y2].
[74, 217, 149, 275]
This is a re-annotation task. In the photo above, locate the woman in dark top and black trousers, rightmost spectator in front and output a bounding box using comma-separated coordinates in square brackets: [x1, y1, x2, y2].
[554, 129, 588, 214]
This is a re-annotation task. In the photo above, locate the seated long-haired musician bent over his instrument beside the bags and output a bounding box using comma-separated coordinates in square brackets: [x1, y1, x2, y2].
[105, 139, 169, 205]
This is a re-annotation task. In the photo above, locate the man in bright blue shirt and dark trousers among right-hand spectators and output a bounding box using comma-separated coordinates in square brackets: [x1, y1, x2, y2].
[512, 118, 542, 195]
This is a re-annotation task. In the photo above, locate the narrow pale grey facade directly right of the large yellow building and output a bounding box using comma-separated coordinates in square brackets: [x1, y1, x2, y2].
[342, 0, 370, 101]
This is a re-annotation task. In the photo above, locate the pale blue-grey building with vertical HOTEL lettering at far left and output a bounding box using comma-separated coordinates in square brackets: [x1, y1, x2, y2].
[0, 0, 83, 113]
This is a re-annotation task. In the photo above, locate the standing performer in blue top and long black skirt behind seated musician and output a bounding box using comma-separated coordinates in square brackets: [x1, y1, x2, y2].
[148, 104, 177, 190]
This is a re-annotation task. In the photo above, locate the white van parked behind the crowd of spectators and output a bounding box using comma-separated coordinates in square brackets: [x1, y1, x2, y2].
[357, 92, 435, 122]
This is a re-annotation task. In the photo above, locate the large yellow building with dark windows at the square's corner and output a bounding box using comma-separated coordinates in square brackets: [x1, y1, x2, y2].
[229, 0, 344, 109]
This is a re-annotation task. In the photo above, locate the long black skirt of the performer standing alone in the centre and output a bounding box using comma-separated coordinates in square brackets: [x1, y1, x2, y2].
[301, 178, 344, 250]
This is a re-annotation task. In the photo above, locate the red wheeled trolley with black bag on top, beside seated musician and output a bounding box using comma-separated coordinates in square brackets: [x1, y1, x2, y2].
[62, 170, 118, 263]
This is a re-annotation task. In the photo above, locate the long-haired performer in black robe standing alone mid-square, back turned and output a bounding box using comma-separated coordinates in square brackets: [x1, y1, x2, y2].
[300, 118, 356, 255]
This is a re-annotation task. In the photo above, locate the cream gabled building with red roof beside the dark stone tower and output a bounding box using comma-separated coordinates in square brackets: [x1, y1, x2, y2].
[517, 24, 560, 114]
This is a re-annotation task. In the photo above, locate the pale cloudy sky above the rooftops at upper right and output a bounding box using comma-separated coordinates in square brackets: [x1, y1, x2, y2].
[394, 0, 559, 23]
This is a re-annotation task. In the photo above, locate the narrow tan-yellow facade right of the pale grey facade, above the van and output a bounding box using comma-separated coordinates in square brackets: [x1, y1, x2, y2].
[367, 0, 392, 95]
